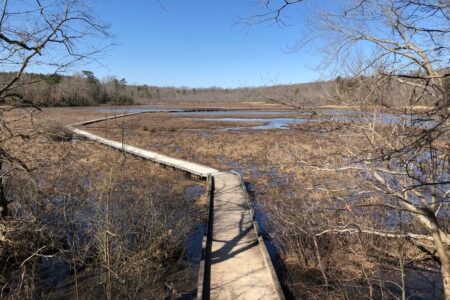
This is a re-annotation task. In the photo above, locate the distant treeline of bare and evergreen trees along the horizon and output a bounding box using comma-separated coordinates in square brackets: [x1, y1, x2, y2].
[0, 71, 450, 107]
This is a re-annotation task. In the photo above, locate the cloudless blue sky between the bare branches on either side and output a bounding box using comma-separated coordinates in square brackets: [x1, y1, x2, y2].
[89, 0, 320, 87]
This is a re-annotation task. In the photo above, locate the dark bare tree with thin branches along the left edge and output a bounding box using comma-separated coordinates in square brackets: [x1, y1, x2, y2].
[0, 0, 110, 216]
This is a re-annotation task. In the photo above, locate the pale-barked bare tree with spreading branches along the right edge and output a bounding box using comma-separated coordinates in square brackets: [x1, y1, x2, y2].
[251, 0, 450, 298]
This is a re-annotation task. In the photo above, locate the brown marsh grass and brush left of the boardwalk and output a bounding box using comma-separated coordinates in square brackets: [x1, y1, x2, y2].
[0, 109, 205, 299]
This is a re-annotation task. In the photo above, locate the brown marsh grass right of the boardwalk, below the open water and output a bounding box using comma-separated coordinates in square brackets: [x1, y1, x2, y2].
[84, 114, 446, 299]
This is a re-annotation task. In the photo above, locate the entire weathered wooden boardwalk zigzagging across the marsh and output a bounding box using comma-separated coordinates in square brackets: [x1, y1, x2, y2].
[67, 113, 284, 299]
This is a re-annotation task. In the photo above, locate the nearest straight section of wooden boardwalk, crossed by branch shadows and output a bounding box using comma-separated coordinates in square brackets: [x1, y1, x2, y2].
[210, 172, 282, 299]
